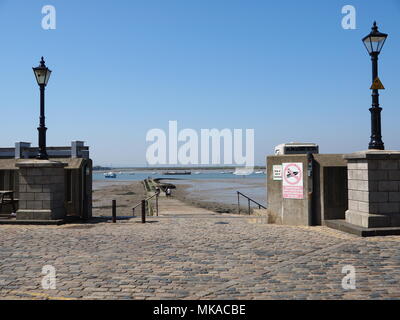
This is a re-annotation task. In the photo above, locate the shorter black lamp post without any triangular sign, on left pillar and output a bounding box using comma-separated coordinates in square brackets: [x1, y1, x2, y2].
[33, 57, 51, 160]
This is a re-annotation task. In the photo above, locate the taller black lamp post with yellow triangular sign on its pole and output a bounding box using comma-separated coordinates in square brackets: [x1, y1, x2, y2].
[362, 22, 388, 150]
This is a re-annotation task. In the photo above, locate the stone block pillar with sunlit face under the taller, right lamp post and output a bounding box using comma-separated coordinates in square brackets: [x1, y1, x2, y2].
[345, 150, 400, 228]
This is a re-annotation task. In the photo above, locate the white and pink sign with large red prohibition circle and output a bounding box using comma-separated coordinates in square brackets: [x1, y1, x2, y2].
[282, 163, 304, 199]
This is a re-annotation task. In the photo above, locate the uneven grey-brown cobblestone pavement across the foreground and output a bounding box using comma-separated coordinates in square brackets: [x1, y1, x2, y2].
[0, 215, 400, 299]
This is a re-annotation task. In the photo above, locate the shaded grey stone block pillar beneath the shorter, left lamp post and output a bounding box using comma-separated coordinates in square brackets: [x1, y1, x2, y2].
[16, 159, 67, 220]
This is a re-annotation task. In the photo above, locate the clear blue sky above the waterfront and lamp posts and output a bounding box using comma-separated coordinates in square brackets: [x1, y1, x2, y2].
[0, 0, 400, 166]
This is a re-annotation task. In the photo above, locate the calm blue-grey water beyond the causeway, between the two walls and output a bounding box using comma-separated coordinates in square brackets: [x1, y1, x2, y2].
[93, 170, 266, 205]
